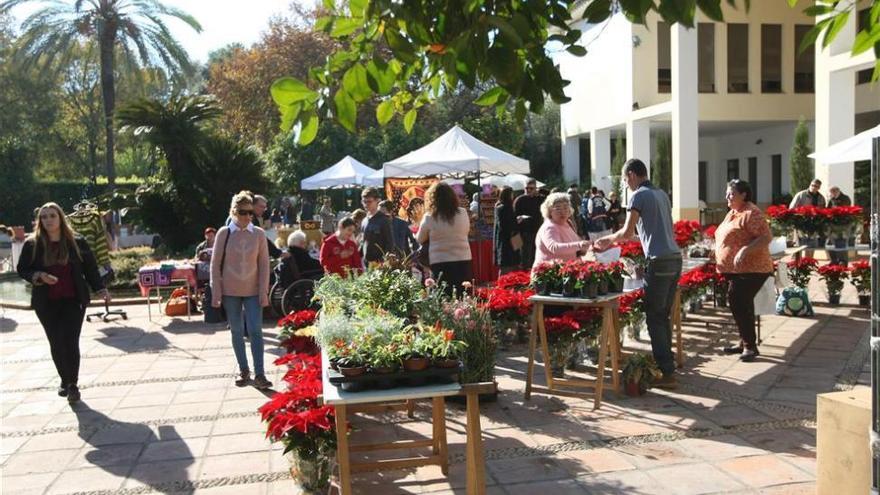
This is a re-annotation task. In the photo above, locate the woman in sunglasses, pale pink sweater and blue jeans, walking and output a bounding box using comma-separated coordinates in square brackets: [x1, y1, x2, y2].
[211, 191, 272, 390]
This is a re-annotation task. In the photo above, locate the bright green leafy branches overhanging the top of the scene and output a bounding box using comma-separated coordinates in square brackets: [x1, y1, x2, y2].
[271, 0, 880, 144]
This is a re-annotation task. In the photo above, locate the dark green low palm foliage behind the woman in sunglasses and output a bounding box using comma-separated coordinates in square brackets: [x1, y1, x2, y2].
[117, 95, 269, 249]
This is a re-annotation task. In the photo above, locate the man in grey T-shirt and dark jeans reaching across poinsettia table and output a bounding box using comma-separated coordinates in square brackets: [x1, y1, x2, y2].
[593, 158, 681, 389]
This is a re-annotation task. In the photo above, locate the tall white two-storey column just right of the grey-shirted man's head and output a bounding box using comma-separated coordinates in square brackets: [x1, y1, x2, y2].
[672, 24, 700, 220]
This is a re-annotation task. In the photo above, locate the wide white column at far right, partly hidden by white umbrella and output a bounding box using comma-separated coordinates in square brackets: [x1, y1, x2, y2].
[816, 16, 856, 198]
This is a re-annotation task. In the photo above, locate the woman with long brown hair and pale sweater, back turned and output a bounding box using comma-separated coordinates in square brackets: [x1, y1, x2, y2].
[417, 182, 472, 293]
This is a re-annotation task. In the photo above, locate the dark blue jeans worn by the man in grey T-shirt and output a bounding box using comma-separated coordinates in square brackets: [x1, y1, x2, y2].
[644, 256, 681, 375]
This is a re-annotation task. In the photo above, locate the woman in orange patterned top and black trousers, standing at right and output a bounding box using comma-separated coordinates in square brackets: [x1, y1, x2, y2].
[715, 179, 773, 362]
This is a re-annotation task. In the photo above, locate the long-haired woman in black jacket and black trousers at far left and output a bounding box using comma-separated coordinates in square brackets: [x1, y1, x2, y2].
[17, 203, 110, 402]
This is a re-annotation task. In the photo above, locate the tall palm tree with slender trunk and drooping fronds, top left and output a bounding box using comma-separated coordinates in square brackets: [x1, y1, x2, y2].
[0, 0, 202, 185]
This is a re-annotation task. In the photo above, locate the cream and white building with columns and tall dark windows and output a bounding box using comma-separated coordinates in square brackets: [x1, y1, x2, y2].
[556, 1, 880, 219]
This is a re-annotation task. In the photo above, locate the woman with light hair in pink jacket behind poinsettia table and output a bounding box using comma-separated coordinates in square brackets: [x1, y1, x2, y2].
[532, 192, 591, 268]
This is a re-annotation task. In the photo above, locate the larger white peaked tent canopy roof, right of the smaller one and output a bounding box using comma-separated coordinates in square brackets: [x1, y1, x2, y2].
[383, 126, 529, 177]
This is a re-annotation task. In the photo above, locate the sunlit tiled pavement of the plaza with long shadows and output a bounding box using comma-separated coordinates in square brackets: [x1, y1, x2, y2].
[0, 280, 868, 495]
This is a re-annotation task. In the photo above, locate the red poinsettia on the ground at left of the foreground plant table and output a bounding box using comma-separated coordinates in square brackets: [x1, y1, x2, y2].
[259, 353, 336, 459]
